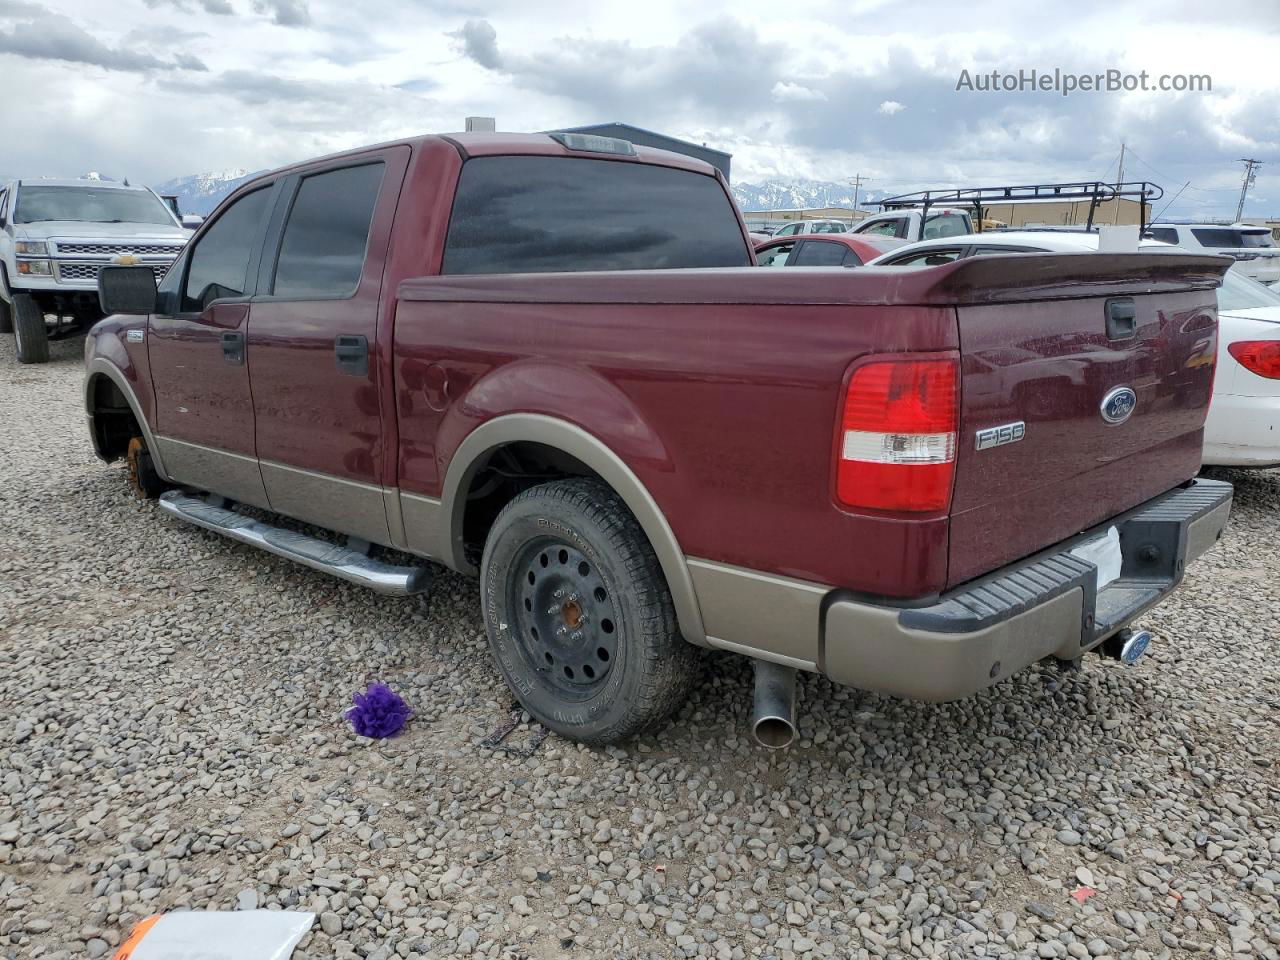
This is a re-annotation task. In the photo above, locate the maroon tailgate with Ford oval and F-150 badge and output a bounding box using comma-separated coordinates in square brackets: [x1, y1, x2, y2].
[947, 253, 1229, 586]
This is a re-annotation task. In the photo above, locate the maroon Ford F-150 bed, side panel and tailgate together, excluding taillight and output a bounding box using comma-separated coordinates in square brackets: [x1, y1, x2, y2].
[394, 255, 1226, 602]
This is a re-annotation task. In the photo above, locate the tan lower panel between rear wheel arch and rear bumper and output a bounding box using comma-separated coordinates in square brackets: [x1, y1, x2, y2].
[689, 558, 831, 671]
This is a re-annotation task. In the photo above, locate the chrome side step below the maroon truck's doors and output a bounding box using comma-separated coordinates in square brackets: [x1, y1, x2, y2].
[160, 490, 431, 596]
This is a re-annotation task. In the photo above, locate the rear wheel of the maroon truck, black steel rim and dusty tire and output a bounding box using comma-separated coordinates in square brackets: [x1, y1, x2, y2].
[480, 479, 699, 745]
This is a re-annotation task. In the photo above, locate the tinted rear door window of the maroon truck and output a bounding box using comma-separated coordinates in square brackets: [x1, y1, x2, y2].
[271, 164, 384, 300]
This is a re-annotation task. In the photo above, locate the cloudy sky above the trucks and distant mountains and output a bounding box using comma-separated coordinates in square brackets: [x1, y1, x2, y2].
[0, 0, 1280, 216]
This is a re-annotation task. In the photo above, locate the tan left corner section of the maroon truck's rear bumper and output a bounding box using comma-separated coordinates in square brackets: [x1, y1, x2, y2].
[823, 589, 1084, 701]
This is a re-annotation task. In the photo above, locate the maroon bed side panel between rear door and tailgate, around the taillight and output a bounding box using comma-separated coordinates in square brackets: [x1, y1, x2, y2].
[394, 293, 955, 594]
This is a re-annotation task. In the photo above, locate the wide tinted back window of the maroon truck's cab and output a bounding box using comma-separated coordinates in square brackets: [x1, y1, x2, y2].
[444, 156, 751, 274]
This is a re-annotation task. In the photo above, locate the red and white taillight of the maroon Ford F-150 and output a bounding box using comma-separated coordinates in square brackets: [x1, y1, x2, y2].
[836, 360, 957, 512]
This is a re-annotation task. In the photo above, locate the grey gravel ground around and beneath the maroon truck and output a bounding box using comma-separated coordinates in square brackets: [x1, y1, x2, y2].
[0, 337, 1280, 960]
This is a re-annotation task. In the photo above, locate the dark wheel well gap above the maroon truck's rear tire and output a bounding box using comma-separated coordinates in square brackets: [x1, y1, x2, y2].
[462, 440, 600, 566]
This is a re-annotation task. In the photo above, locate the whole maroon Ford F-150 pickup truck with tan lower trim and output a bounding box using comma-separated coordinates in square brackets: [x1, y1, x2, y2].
[84, 134, 1231, 745]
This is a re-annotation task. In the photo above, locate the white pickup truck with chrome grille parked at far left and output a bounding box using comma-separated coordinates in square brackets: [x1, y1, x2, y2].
[0, 179, 189, 364]
